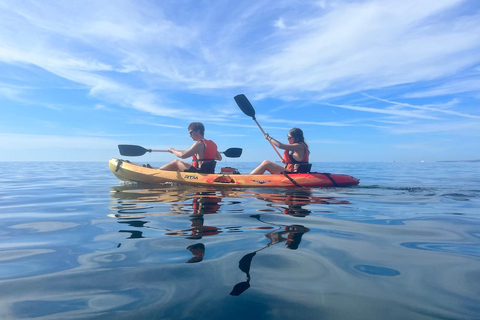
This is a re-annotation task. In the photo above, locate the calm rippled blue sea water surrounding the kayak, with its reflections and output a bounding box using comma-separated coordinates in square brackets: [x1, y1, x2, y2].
[0, 161, 480, 319]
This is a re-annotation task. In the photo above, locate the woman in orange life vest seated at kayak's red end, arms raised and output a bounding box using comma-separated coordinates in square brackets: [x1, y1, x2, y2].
[250, 128, 310, 174]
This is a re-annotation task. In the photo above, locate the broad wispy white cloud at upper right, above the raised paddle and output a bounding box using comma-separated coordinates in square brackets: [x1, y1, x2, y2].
[248, 0, 480, 95]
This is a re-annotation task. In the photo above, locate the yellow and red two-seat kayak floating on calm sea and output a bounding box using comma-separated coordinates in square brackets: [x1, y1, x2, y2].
[109, 158, 359, 188]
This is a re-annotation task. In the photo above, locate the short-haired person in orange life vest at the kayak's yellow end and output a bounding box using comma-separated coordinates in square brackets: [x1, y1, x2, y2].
[160, 122, 222, 173]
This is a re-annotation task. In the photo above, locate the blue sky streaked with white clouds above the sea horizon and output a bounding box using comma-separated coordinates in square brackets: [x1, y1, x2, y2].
[0, 0, 480, 163]
